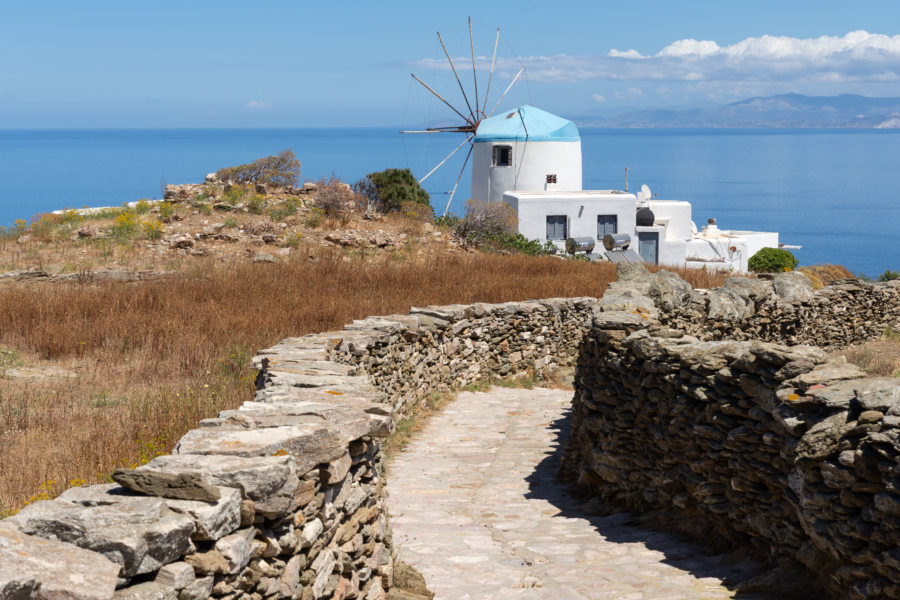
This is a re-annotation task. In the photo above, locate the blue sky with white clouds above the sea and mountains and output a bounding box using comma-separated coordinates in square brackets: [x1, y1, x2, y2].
[0, 0, 900, 128]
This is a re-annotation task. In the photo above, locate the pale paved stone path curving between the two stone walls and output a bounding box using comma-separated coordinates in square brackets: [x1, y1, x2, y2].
[387, 388, 772, 600]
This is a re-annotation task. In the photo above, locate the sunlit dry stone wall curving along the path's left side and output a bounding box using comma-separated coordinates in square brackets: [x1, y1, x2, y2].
[0, 298, 596, 600]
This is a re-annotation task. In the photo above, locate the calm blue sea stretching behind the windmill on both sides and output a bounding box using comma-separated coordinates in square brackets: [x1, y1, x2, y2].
[0, 128, 900, 277]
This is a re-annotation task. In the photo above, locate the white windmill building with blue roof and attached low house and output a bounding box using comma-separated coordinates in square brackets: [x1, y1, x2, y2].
[472, 106, 778, 272]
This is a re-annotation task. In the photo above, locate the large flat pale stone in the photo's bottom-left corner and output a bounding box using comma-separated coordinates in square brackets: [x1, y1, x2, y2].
[0, 521, 119, 600]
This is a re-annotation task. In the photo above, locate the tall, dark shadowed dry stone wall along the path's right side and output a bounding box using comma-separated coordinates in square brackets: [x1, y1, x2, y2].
[564, 271, 900, 598]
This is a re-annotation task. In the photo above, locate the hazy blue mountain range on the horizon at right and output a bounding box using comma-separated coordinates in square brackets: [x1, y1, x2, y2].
[574, 94, 900, 129]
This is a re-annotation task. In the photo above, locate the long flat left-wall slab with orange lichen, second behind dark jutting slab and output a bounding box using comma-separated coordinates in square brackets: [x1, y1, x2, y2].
[175, 423, 348, 473]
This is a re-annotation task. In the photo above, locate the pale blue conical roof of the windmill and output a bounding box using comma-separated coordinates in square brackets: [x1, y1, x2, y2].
[472, 105, 581, 143]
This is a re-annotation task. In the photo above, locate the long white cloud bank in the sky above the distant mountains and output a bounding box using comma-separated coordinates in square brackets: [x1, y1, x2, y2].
[416, 31, 900, 83]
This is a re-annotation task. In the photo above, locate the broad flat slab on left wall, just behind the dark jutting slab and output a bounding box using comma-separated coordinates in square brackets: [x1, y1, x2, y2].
[138, 454, 300, 518]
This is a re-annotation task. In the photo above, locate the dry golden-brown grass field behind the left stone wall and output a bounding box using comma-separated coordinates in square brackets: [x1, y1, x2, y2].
[0, 253, 725, 512]
